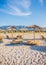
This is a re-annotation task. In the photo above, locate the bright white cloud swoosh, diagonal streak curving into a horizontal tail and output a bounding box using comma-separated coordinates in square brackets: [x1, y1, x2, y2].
[8, 5, 32, 16]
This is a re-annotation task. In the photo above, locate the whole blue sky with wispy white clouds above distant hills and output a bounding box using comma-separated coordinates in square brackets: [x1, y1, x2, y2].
[0, 0, 46, 27]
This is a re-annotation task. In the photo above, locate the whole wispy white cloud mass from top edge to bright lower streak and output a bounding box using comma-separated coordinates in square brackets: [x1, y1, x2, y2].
[0, 0, 32, 16]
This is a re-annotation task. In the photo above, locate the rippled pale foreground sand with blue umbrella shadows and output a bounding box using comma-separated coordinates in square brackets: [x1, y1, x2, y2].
[0, 43, 46, 65]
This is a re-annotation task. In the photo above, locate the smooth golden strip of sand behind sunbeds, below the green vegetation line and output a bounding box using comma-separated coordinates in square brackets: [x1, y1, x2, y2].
[0, 32, 46, 39]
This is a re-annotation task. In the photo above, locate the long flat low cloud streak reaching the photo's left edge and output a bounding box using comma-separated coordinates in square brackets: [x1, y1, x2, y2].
[0, 9, 32, 16]
